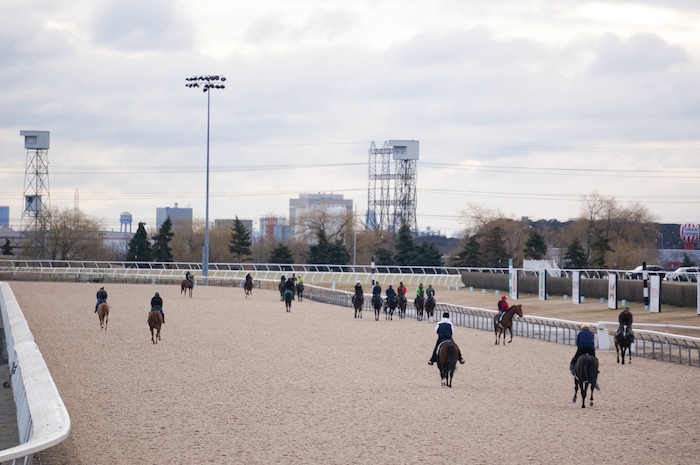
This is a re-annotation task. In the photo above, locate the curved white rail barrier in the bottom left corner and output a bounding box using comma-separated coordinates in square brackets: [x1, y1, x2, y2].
[0, 282, 70, 464]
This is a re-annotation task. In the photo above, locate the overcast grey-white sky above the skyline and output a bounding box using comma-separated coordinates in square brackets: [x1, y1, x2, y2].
[0, 0, 700, 234]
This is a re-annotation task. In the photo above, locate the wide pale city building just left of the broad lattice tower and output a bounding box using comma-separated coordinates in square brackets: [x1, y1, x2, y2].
[292, 192, 353, 240]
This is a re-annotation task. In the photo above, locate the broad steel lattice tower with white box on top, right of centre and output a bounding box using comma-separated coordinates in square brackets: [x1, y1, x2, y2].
[366, 140, 418, 231]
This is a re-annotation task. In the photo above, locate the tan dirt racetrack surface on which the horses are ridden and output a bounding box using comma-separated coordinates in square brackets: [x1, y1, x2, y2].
[6, 282, 700, 465]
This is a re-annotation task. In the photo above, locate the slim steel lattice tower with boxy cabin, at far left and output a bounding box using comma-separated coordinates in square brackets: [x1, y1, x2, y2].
[19, 131, 51, 260]
